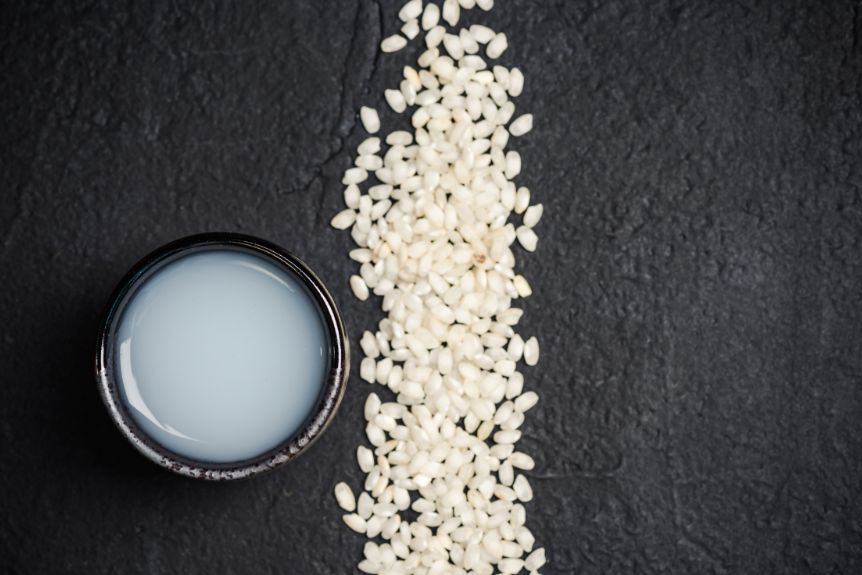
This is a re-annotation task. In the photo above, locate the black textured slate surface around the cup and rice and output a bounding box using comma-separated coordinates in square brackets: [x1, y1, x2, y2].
[0, 0, 862, 575]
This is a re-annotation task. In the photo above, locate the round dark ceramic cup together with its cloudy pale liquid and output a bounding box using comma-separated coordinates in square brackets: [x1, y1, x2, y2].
[96, 234, 349, 480]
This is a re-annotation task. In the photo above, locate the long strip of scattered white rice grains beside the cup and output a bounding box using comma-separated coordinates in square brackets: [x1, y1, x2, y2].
[332, 0, 545, 575]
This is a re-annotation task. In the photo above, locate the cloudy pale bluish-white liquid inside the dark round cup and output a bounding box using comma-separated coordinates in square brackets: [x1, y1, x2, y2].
[115, 248, 329, 463]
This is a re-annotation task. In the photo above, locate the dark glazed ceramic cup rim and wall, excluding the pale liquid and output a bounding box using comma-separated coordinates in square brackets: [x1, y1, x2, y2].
[96, 233, 350, 481]
